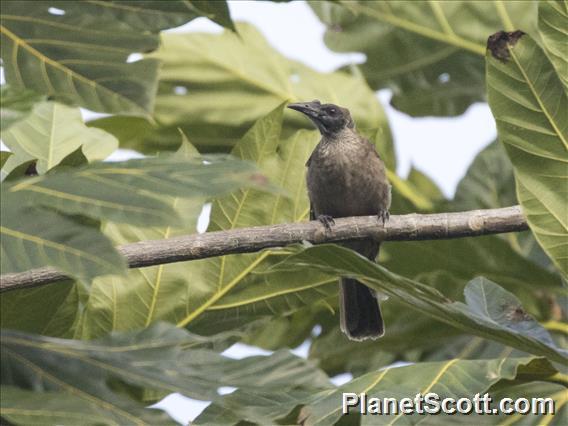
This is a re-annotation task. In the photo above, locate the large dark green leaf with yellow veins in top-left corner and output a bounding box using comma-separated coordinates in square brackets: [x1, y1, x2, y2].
[1, 0, 232, 116]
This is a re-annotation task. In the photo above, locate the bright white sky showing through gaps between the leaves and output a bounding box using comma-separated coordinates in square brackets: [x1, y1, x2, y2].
[151, 1, 497, 424]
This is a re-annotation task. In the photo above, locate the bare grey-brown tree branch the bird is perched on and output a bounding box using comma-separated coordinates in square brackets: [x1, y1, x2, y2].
[0, 206, 528, 292]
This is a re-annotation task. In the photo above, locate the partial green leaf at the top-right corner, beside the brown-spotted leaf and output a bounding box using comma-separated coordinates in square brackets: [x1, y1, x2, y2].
[538, 0, 568, 90]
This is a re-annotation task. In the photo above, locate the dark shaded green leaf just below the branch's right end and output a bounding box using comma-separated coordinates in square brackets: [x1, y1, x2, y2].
[381, 236, 565, 319]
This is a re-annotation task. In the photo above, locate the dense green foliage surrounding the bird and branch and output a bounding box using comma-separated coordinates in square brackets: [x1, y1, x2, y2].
[2, 1, 568, 424]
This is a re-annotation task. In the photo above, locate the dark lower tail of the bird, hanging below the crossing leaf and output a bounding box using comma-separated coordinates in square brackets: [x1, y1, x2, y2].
[339, 278, 385, 341]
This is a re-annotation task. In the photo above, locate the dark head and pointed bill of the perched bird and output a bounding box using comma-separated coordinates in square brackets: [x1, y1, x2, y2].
[288, 100, 355, 136]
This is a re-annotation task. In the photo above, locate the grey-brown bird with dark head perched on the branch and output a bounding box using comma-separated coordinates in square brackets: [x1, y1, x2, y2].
[288, 100, 391, 341]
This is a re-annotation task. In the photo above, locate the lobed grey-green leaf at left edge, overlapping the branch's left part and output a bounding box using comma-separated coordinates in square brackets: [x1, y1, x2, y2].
[1, 156, 262, 281]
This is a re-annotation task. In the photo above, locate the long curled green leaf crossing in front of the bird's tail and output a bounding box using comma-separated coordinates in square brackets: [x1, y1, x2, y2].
[272, 245, 568, 362]
